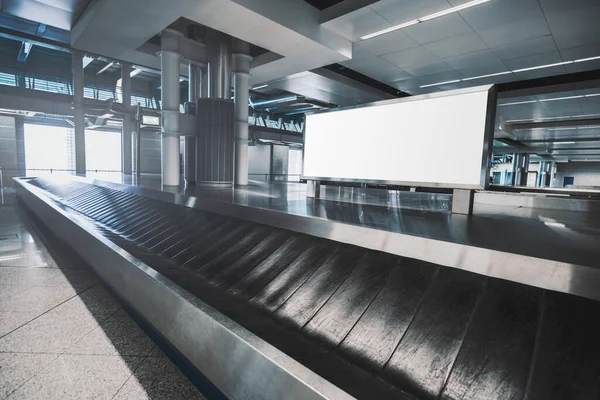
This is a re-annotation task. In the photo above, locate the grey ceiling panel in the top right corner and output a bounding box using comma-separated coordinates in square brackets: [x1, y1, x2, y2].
[540, 0, 600, 49]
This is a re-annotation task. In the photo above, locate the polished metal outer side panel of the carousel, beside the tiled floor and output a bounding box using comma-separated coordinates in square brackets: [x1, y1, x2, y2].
[17, 179, 351, 399]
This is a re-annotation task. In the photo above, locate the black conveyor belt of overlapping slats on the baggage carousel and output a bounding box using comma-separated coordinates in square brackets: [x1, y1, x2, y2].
[18, 178, 600, 399]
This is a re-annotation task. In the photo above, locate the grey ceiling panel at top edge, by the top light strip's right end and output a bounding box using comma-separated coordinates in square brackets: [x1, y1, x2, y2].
[460, 0, 550, 47]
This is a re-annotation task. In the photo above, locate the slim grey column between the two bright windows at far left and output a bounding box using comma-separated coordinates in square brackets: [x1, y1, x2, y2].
[72, 50, 86, 174]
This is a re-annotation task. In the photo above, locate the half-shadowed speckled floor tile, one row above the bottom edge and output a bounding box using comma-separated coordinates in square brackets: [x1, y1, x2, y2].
[66, 311, 154, 356]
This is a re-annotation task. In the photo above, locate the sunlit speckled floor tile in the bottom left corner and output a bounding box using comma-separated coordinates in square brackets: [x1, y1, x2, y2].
[0, 353, 58, 399]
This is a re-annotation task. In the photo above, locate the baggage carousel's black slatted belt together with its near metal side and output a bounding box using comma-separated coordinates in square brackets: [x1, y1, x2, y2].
[16, 178, 600, 399]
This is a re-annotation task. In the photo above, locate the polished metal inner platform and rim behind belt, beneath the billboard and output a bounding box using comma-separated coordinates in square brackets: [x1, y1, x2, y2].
[41, 178, 600, 299]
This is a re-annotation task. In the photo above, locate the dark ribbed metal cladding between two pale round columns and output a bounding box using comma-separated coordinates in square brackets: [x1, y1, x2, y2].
[196, 98, 234, 186]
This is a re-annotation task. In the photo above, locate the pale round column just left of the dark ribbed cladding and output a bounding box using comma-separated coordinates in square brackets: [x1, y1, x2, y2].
[160, 29, 183, 186]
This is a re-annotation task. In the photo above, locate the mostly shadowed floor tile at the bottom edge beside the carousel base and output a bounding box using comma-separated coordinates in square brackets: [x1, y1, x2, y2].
[115, 357, 204, 400]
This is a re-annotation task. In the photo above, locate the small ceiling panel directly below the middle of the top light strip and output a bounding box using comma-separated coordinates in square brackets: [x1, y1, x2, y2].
[403, 14, 473, 44]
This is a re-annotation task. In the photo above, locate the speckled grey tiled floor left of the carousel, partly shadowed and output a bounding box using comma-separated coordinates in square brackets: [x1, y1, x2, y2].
[0, 192, 203, 400]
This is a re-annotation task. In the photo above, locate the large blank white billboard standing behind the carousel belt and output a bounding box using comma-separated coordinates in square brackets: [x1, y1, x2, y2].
[303, 86, 490, 188]
